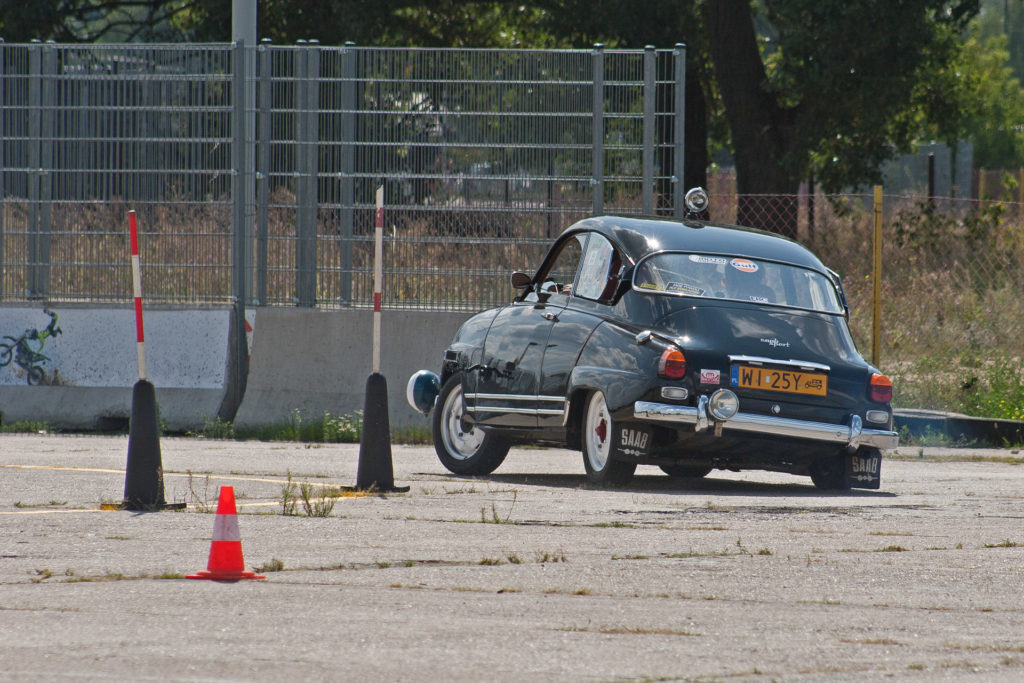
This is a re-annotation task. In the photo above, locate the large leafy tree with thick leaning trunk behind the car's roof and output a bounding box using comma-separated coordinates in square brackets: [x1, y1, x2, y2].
[705, 0, 978, 234]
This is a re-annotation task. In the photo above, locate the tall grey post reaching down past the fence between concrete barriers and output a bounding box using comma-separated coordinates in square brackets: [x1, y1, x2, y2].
[231, 40, 249, 407]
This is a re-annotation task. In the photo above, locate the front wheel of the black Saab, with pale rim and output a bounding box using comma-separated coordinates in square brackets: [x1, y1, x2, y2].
[433, 375, 510, 476]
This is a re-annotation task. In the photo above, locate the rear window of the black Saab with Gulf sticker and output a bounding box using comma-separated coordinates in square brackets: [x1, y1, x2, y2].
[633, 253, 844, 313]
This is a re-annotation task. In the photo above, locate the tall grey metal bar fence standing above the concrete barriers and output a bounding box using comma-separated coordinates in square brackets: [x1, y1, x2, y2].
[0, 42, 685, 309]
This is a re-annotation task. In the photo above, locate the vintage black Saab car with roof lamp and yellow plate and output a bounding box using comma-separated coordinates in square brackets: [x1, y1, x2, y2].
[408, 190, 897, 488]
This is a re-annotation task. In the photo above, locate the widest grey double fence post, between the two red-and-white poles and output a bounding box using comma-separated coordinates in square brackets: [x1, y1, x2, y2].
[295, 41, 319, 306]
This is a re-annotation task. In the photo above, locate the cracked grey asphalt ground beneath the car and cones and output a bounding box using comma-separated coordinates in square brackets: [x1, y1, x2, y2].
[0, 434, 1024, 681]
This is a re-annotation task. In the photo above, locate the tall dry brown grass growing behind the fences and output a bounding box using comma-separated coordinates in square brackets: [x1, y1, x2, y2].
[6, 187, 1024, 419]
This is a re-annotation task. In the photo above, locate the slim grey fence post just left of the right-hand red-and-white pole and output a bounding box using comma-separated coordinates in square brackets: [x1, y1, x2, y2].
[339, 42, 358, 303]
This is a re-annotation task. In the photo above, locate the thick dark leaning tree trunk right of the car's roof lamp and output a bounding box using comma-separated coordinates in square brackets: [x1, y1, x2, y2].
[706, 0, 803, 238]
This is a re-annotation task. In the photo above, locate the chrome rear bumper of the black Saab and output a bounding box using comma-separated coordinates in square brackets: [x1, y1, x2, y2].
[633, 396, 899, 452]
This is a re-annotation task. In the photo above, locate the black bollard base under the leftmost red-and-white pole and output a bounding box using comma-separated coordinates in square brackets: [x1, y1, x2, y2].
[121, 380, 184, 510]
